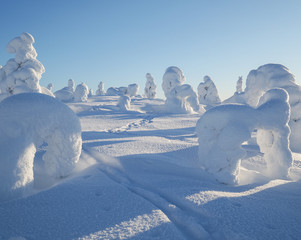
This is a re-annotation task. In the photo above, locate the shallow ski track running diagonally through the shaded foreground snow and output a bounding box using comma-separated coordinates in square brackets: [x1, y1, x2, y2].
[86, 150, 211, 240]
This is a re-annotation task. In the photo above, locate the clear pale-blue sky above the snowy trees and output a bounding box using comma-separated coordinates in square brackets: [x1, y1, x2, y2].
[0, 0, 301, 99]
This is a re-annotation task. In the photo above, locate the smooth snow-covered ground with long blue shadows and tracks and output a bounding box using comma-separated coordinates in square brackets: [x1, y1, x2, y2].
[0, 96, 301, 240]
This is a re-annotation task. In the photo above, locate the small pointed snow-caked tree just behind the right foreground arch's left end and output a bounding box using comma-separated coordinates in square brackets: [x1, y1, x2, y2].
[198, 76, 221, 106]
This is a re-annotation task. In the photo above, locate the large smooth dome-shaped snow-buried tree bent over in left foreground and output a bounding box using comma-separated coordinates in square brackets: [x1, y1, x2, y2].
[0, 93, 82, 200]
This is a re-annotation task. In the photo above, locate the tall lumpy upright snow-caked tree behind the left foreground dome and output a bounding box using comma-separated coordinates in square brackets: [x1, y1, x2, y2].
[0, 33, 45, 99]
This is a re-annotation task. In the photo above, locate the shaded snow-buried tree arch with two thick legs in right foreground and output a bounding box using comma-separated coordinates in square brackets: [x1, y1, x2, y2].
[196, 89, 293, 184]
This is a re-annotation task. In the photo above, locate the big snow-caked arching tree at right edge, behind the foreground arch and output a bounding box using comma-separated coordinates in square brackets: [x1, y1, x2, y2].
[244, 64, 301, 152]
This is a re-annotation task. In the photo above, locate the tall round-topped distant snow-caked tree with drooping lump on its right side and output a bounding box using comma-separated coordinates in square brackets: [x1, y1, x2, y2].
[162, 67, 204, 113]
